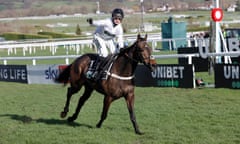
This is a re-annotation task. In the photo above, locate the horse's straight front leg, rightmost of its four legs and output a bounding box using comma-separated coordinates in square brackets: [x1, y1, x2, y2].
[125, 94, 143, 134]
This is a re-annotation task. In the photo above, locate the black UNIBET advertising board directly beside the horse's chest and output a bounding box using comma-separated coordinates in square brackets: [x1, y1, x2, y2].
[135, 64, 195, 88]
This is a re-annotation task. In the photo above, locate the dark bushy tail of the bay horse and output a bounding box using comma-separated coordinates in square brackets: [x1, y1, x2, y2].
[55, 64, 72, 85]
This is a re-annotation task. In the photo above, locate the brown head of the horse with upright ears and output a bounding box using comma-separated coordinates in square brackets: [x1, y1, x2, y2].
[135, 34, 157, 71]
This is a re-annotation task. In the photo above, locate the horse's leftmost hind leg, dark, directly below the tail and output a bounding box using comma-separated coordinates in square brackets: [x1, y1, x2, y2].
[60, 87, 79, 118]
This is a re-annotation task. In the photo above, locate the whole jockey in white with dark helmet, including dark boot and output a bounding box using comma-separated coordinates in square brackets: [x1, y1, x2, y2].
[86, 8, 124, 80]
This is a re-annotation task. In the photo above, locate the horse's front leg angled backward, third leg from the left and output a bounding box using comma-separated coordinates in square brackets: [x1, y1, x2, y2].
[97, 96, 113, 128]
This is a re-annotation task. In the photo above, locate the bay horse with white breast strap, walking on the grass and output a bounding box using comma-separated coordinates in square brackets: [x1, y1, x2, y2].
[55, 34, 156, 134]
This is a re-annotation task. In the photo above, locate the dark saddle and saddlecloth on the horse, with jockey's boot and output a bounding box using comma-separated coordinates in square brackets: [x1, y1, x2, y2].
[85, 55, 117, 81]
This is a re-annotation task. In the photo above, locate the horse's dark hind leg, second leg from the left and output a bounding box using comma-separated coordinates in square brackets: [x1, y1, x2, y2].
[68, 85, 93, 122]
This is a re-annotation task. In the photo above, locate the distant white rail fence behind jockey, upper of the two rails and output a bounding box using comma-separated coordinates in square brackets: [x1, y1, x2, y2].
[0, 33, 197, 56]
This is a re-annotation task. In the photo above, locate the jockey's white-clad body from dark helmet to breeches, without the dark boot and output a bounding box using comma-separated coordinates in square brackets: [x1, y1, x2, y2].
[87, 8, 124, 57]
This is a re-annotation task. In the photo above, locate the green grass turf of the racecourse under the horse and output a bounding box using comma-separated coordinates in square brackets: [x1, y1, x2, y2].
[0, 82, 240, 144]
